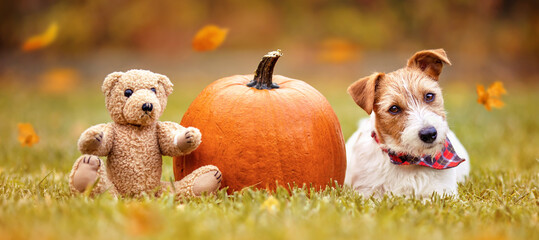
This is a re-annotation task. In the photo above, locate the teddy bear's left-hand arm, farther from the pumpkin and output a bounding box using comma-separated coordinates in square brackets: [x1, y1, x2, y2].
[78, 123, 114, 156]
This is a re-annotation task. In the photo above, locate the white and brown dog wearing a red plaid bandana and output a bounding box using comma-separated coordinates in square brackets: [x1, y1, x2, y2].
[345, 49, 470, 197]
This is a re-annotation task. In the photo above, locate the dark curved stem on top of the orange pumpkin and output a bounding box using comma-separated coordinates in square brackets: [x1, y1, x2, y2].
[247, 49, 283, 90]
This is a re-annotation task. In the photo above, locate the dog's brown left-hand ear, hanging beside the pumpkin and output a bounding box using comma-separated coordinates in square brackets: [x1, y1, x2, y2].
[348, 73, 385, 114]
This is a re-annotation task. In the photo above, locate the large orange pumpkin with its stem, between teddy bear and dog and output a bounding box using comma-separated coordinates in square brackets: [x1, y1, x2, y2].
[174, 51, 346, 192]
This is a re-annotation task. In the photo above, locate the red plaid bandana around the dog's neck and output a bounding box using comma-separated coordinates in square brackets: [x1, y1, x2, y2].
[371, 131, 465, 170]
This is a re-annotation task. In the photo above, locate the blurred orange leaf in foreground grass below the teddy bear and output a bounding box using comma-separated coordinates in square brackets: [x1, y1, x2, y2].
[126, 202, 163, 236]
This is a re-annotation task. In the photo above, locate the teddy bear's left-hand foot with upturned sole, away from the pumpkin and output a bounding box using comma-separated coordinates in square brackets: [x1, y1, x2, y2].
[73, 155, 101, 192]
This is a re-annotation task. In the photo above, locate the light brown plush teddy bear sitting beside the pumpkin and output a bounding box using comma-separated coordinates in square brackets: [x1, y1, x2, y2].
[69, 70, 222, 196]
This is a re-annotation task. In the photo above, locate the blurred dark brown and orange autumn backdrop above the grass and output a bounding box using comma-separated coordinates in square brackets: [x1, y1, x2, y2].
[0, 0, 539, 82]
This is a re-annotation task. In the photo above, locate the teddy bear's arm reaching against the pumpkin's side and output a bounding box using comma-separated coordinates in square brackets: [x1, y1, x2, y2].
[157, 122, 201, 156]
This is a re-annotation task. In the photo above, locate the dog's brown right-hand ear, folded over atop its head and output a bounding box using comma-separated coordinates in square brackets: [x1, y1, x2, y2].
[408, 48, 451, 81]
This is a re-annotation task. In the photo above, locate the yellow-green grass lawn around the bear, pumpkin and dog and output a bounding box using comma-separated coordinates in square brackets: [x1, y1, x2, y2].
[0, 82, 539, 239]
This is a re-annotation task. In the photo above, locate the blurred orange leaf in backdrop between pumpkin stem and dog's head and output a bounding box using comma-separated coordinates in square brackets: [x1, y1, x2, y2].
[318, 38, 359, 63]
